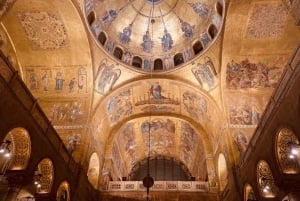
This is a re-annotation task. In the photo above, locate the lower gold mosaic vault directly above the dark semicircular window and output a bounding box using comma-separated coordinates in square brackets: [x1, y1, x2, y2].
[111, 116, 207, 179]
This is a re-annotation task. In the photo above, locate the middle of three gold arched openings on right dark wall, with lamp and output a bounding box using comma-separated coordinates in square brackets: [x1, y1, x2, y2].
[256, 160, 277, 198]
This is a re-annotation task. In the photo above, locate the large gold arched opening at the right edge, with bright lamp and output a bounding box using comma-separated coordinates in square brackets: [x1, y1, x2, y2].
[275, 128, 300, 174]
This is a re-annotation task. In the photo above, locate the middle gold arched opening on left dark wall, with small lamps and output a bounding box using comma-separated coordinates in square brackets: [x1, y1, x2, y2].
[33, 158, 54, 194]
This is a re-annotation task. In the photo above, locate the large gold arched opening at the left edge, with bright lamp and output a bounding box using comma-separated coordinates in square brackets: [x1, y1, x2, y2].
[0, 127, 31, 172]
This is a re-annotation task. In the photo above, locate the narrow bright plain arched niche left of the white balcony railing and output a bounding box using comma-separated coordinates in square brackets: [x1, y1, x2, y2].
[87, 153, 100, 189]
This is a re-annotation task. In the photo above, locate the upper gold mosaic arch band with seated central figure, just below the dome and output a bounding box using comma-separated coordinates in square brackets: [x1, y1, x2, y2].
[93, 79, 222, 152]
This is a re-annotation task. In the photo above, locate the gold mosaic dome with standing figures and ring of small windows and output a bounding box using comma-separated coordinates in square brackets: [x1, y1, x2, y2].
[85, 0, 224, 71]
